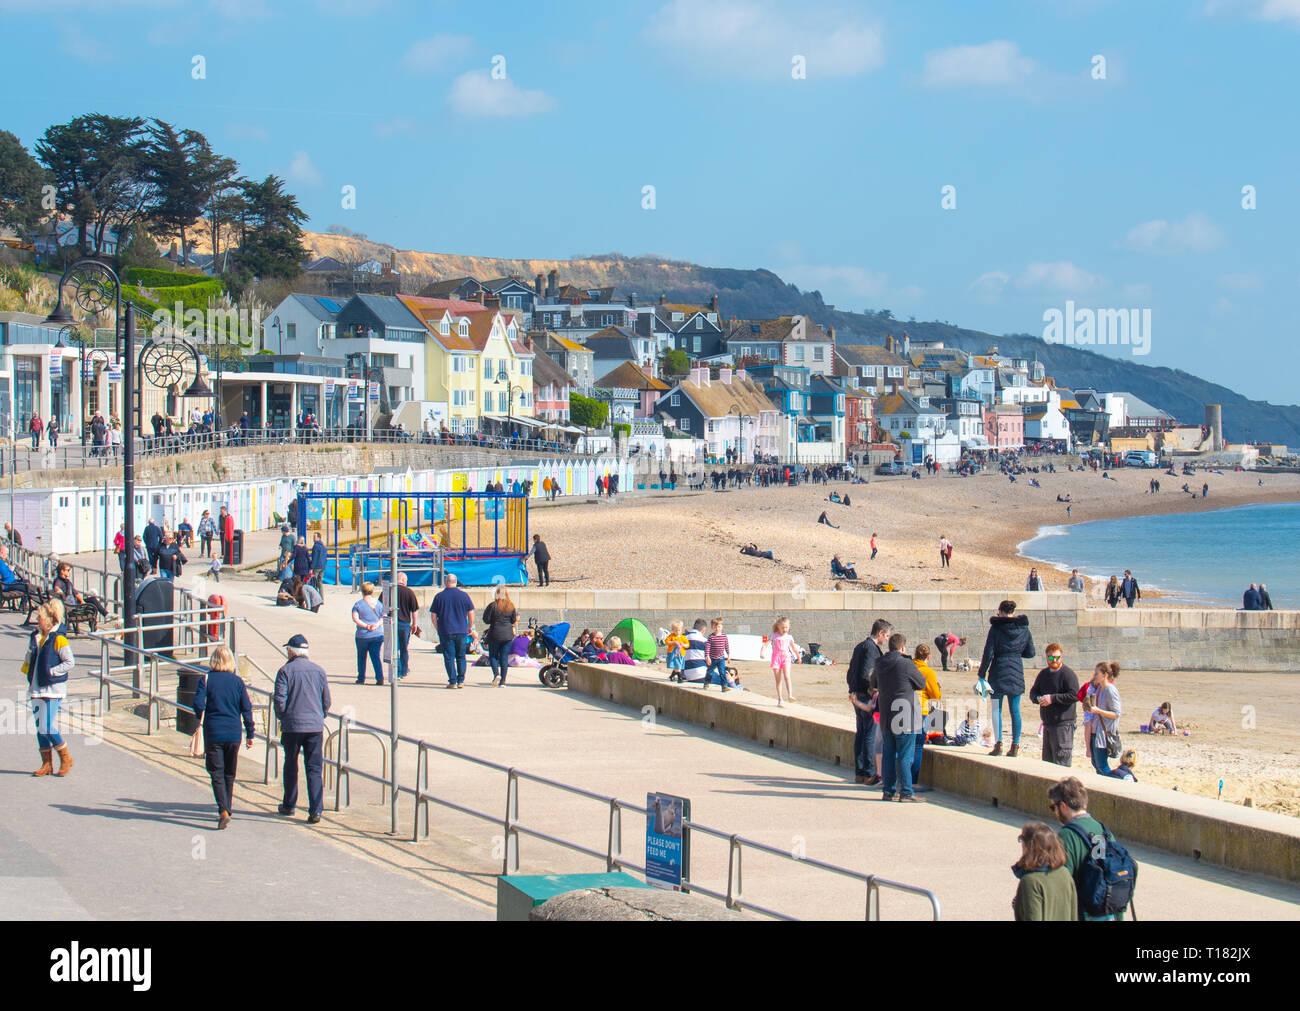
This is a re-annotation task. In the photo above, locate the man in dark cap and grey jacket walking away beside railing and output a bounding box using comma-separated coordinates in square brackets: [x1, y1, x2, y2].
[276, 635, 330, 825]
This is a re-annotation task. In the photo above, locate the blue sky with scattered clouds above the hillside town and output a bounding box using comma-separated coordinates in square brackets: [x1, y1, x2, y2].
[0, 0, 1300, 403]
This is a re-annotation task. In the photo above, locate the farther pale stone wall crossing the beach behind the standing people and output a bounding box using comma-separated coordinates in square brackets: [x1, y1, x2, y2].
[471, 589, 1300, 672]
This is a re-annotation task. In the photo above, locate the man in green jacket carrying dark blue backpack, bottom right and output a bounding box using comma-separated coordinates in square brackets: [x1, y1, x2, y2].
[1048, 776, 1138, 920]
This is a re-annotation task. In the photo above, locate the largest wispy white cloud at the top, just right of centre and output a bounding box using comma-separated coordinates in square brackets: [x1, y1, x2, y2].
[646, 0, 884, 81]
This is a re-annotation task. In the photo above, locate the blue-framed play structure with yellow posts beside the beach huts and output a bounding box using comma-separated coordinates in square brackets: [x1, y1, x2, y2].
[298, 491, 529, 586]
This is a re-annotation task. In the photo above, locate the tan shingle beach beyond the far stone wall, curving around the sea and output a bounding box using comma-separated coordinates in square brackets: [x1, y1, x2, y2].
[529, 465, 1300, 597]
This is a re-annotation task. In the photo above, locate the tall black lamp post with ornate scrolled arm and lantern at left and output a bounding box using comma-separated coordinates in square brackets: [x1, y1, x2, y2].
[46, 260, 139, 665]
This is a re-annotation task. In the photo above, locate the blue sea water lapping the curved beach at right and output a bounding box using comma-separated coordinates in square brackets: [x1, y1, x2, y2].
[1021, 503, 1300, 609]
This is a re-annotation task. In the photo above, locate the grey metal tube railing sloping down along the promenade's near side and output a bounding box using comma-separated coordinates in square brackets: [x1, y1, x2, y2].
[78, 616, 940, 920]
